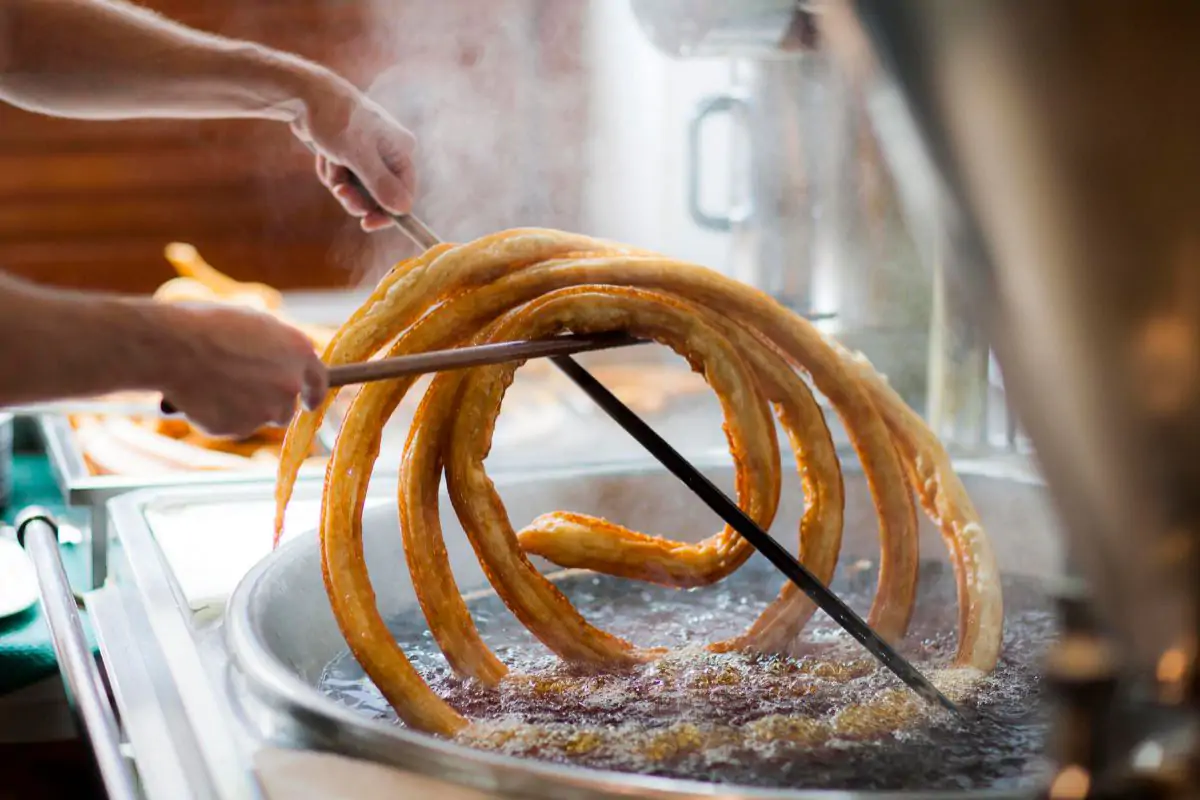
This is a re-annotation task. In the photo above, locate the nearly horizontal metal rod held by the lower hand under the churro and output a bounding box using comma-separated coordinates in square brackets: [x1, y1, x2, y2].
[329, 333, 644, 387]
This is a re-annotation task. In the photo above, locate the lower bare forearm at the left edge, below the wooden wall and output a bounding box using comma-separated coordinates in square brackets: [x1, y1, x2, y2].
[0, 276, 186, 405]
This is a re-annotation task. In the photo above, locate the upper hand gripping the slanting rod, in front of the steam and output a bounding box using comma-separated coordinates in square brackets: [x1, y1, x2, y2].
[292, 79, 416, 231]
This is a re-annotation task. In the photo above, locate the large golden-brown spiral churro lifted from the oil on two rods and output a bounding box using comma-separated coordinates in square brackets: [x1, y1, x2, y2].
[276, 229, 1002, 735]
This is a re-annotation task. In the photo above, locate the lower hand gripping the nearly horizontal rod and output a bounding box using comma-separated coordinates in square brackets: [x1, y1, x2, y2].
[163, 305, 329, 438]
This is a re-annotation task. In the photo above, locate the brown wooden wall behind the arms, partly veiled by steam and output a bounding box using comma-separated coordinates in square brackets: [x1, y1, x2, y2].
[0, 0, 588, 291]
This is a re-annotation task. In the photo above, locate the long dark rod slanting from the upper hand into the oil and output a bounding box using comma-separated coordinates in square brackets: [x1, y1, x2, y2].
[352, 184, 962, 717]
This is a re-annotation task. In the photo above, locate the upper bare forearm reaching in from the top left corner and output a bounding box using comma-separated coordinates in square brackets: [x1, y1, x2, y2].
[0, 0, 343, 122]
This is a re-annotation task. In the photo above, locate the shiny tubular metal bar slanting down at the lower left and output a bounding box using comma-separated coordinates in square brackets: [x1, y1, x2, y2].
[16, 507, 138, 800]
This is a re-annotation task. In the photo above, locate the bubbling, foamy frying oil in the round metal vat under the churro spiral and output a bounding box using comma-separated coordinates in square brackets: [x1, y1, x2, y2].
[322, 558, 1054, 790]
